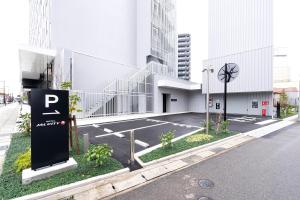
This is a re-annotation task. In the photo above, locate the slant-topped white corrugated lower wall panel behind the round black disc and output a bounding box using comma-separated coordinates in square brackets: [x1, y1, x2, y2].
[203, 47, 273, 94]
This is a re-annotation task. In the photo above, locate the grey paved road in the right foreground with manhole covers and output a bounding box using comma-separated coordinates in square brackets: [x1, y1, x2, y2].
[114, 124, 300, 200]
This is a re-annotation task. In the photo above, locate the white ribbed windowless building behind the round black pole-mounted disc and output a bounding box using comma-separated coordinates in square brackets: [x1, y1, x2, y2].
[203, 0, 273, 115]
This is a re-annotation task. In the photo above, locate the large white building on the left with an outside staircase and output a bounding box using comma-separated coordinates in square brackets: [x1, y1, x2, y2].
[20, 0, 204, 117]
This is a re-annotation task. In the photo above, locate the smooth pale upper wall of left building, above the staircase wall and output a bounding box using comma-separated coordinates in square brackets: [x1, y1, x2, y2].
[50, 0, 137, 65]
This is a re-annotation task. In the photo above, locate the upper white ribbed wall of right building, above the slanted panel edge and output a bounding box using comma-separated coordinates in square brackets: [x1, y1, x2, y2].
[208, 0, 273, 59]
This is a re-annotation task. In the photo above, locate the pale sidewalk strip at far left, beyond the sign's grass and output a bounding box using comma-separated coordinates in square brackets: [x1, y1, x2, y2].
[0, 103, 20, 174]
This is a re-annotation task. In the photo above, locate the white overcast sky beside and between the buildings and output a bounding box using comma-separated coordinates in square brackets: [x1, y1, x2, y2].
[0, 0, 300, 95]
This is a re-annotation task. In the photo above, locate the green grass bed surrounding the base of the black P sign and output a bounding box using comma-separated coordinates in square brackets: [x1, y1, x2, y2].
[0, 134, 123, 199]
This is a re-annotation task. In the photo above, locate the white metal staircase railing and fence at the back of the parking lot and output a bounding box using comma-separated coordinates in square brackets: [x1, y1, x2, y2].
[72, 58, 177, 118]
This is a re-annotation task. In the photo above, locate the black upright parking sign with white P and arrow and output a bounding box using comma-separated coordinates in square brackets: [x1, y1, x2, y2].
[31, 89, 69, 170]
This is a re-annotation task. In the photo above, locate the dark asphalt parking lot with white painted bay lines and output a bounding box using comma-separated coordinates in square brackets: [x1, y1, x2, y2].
[79, 113, 273, 167]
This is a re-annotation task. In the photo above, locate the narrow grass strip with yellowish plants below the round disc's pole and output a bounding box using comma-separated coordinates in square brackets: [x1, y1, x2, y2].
[140, 130, 237, 162]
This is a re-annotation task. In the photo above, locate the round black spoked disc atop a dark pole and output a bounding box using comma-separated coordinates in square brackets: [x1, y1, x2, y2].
[218, 63, 240, 83]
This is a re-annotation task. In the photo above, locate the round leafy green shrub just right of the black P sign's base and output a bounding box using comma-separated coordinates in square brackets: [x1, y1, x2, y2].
[85, 144, 112, 166]
